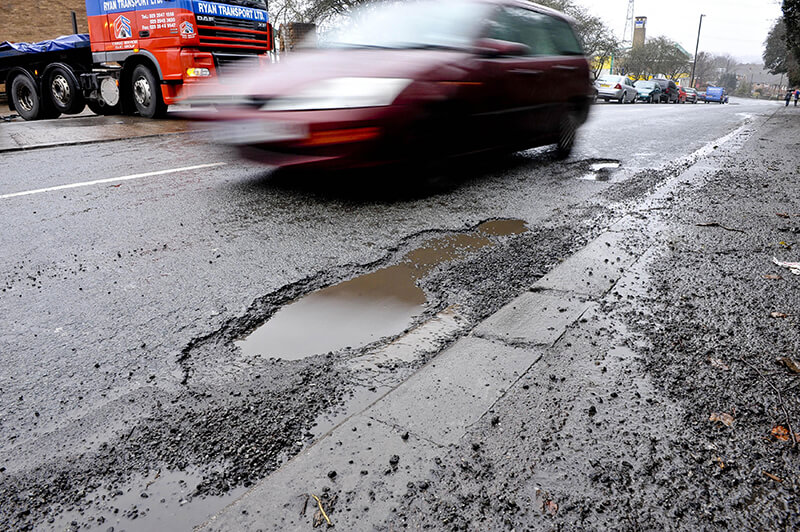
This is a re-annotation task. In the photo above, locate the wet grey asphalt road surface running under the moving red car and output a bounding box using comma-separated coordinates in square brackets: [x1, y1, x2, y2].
[0, 100, 775, 530]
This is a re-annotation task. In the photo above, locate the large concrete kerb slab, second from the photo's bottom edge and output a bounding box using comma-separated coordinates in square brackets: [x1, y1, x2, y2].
[365, 337, 541, 445]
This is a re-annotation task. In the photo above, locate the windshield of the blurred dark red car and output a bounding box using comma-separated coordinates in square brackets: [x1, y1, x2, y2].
[319, 0, 492, 49]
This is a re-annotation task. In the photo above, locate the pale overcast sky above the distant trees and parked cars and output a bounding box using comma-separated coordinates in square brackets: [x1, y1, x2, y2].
[577, 0, 781, 63]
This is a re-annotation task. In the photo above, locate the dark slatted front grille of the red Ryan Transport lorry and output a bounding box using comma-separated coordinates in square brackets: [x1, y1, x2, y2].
[197, 15, 272, 54]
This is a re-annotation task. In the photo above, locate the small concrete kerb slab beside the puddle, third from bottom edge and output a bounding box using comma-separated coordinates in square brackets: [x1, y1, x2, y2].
[472, 291, 592, 346]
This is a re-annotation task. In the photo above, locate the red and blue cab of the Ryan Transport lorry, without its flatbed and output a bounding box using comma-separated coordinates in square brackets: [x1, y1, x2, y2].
[86, 0, 272, 116]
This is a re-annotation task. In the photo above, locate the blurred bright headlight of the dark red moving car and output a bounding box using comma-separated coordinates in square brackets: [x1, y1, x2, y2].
[261, 78, 411, 111]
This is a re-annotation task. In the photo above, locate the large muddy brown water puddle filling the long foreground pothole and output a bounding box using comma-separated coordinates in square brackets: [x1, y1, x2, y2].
[235, 220, 527, 360]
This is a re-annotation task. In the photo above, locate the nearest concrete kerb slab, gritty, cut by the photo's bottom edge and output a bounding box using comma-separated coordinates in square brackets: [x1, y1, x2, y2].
[195, 416, 443, 532]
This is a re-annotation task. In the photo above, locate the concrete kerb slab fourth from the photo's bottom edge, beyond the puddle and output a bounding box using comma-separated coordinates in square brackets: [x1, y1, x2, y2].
[533, 231, 642, 297]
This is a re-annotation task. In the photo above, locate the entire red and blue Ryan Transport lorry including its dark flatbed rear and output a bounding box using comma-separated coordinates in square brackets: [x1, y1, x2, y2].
[0, 0, 273, 120]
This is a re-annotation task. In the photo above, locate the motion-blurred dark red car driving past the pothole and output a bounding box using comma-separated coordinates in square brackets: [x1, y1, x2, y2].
[194, 0, 593, 168]
